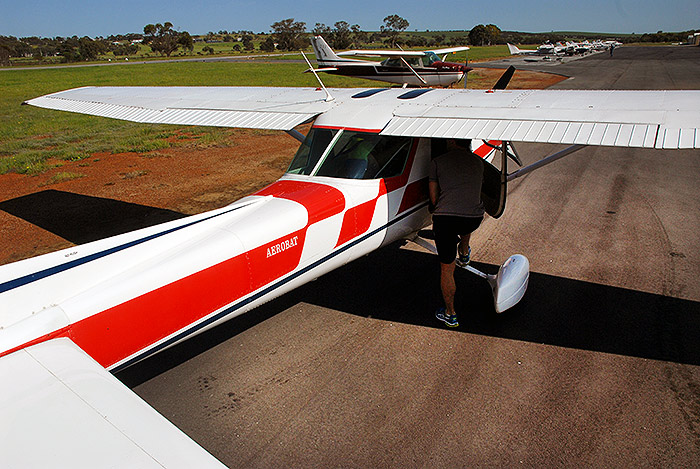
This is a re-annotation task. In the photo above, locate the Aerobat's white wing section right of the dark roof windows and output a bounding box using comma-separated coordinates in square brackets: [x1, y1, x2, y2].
[382, 90, 700, 149]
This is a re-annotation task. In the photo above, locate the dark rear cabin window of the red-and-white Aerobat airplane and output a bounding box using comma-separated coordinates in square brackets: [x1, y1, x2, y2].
[288, 128, 411, 179]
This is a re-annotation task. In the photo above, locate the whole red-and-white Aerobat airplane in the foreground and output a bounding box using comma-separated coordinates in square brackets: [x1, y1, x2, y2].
[0, 78, 700, 467]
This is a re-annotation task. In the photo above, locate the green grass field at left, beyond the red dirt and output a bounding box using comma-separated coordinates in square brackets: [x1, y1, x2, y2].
[0, 46, 507, 174]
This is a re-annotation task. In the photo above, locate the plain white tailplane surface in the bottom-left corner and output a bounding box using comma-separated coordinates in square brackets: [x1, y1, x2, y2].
[0, 339, 225, 468]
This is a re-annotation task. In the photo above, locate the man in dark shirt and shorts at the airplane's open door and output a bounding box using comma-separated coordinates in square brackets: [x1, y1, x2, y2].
[429, 139, 484, 327]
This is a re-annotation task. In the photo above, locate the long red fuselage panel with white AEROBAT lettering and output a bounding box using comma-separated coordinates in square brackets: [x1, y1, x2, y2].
[70, 228, 306, 367]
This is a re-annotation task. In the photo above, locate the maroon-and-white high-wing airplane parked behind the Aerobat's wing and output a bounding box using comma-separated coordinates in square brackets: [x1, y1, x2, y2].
[311, 36, 471, 86]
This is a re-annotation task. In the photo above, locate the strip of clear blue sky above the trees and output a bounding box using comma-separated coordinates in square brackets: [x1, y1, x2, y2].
[0, 0, 700, 38]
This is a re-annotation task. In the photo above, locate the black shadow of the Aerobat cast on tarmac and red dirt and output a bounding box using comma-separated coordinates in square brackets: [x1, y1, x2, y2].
[9, 190, 700, 386]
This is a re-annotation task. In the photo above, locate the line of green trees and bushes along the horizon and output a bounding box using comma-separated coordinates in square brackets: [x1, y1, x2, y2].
[0, 15, 696, 65]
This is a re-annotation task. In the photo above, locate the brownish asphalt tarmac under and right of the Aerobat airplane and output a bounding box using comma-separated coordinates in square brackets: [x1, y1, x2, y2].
[118, 47, 700, 468]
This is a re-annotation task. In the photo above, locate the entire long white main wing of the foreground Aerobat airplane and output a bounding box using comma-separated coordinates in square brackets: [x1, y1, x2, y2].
[27, 87, 700, 149]
